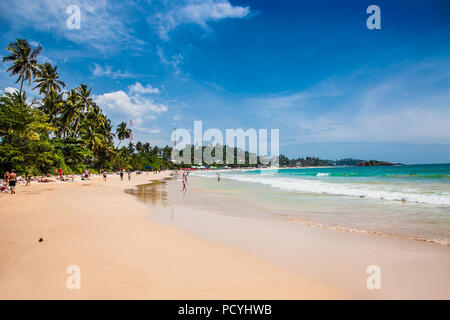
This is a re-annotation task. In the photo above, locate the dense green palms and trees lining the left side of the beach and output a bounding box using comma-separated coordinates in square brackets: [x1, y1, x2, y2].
[0, 39, 174, 175]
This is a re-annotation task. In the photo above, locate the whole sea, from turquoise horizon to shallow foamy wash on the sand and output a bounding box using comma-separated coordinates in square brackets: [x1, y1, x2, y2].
[190, 164, 450, 245]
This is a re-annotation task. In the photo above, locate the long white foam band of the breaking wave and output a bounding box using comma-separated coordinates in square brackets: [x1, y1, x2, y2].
[219, 174, 450, 206]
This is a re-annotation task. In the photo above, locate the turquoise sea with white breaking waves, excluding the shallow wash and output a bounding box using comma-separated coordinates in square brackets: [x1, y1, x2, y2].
[206, 164, 450, 206]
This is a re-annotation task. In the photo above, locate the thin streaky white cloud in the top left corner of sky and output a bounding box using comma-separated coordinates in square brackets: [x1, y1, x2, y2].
[0, 0, 142, 52]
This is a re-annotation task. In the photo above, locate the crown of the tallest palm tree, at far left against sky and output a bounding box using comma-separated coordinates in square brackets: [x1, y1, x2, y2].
[3, 39, 42, 95]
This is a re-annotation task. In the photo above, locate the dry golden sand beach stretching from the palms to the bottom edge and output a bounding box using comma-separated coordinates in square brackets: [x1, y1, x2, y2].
[0, 173, 342, 299]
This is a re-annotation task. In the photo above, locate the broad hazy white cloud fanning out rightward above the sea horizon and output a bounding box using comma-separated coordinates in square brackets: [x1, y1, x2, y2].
[247, 61, 450, 144]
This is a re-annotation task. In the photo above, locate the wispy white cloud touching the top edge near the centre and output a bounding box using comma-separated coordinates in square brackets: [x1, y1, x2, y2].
[148, 0, 250, 40]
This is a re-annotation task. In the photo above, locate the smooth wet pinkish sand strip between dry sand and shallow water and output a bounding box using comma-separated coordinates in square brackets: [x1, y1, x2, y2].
[130, 177, 450, 299]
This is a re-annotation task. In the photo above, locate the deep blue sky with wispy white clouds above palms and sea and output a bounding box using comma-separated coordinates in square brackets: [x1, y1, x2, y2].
[0, 0, 450, 163]
